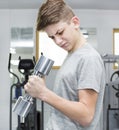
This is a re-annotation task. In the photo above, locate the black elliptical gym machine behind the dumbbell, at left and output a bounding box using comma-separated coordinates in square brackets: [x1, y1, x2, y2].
[8, 53, 40, 130]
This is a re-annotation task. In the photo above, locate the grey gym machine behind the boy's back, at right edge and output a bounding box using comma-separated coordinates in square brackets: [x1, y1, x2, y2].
[102, 54, 119, 130]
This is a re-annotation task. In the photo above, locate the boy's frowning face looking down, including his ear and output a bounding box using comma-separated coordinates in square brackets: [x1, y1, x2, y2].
[45, 17, 79, 52]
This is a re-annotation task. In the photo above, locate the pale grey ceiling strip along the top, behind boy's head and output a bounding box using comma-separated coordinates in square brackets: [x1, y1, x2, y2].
[0, 0, 119, 10]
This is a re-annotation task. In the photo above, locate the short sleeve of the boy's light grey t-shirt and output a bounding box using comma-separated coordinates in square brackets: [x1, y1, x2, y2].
[78, 55, 103, 92]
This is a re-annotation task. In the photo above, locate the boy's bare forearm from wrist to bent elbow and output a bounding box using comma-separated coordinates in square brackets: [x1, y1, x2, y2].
[39, 89, 93, 126]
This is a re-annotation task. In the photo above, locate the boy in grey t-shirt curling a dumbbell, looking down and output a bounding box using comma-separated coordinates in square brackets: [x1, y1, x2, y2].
[25, 0, 105, 130]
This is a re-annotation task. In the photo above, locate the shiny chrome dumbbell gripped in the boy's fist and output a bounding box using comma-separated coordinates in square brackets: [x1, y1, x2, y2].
[12, 55, 54, 118]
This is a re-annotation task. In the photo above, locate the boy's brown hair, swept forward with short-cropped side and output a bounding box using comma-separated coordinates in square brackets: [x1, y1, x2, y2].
[36, 0, 74, 31]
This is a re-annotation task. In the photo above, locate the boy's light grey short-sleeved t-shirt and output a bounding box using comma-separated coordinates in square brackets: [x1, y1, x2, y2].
[46, 43, 105, 130]
